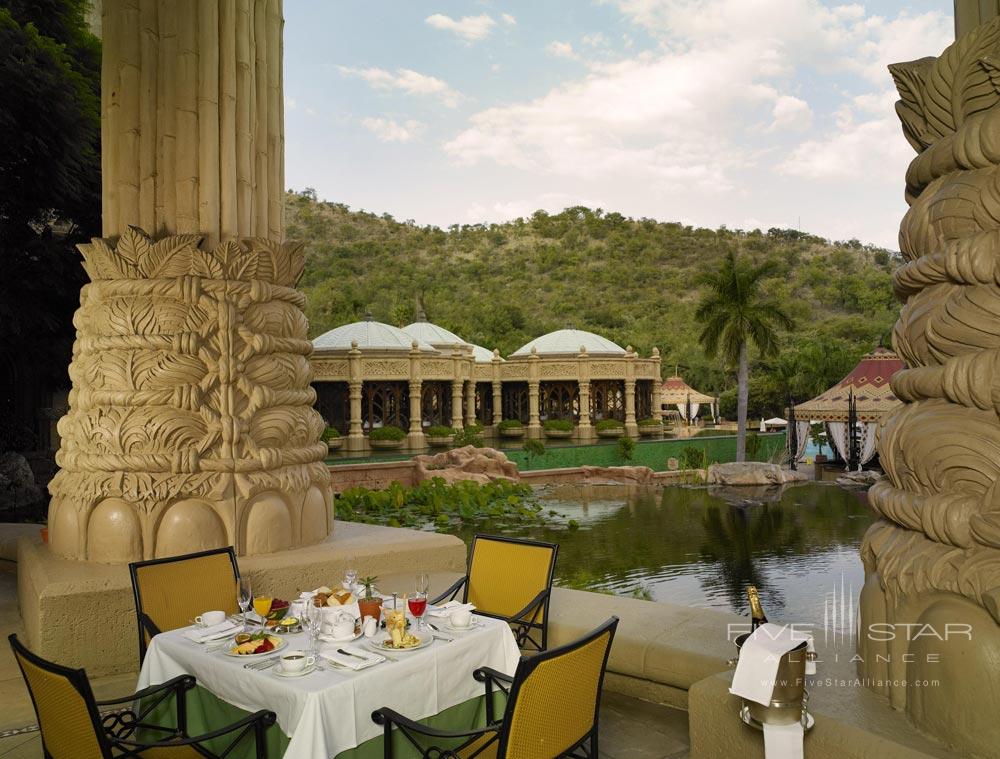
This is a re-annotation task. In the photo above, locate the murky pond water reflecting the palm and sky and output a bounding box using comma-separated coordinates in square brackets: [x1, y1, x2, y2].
[462, 482, 875, 625]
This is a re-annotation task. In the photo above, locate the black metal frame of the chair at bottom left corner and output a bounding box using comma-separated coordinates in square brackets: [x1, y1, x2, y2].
[7, 634, 276, 759]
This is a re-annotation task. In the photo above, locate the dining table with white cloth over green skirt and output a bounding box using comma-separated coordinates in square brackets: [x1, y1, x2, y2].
[138, 615, 520, 759]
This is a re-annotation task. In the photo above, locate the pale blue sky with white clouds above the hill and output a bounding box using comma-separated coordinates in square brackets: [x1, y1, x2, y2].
[285, 0, 953, 248]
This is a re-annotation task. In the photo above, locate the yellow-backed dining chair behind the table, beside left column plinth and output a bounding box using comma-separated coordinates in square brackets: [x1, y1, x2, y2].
[128, 546, 240, 664]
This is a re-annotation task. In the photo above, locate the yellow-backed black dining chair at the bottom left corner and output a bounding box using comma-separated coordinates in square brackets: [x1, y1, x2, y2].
[7, 635, 275, 759]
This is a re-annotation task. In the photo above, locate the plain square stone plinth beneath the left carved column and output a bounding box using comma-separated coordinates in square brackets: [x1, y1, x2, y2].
[17, 522, 466, 677]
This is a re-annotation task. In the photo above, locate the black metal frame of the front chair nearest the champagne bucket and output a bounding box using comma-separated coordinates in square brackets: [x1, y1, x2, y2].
[372, 617, 618, 759]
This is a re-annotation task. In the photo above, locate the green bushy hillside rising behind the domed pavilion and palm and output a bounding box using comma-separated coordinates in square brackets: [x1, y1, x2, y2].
[286, 190, 898, 416]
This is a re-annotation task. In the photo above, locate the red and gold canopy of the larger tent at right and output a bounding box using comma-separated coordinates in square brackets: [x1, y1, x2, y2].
[794, 347, 903, 422]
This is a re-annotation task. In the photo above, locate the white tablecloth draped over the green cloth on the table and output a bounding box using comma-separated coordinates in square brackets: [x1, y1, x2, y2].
[138, 617, 520, 759]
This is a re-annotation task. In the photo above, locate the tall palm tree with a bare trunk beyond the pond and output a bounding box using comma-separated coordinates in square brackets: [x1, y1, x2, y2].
[695, 250, 792, 461]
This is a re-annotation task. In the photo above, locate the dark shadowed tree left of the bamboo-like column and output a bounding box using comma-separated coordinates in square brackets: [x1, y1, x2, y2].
[0, 0, 101, 451]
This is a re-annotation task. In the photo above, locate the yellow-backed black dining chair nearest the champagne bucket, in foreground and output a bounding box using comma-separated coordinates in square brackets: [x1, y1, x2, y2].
[372, 617, 618, 759]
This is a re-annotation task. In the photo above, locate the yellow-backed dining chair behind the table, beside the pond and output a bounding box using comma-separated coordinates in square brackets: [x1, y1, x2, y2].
[431, 534, 559, 651]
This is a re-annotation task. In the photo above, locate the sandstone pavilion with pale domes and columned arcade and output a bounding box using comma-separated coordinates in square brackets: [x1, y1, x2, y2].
[311, 314, 661, 452]
